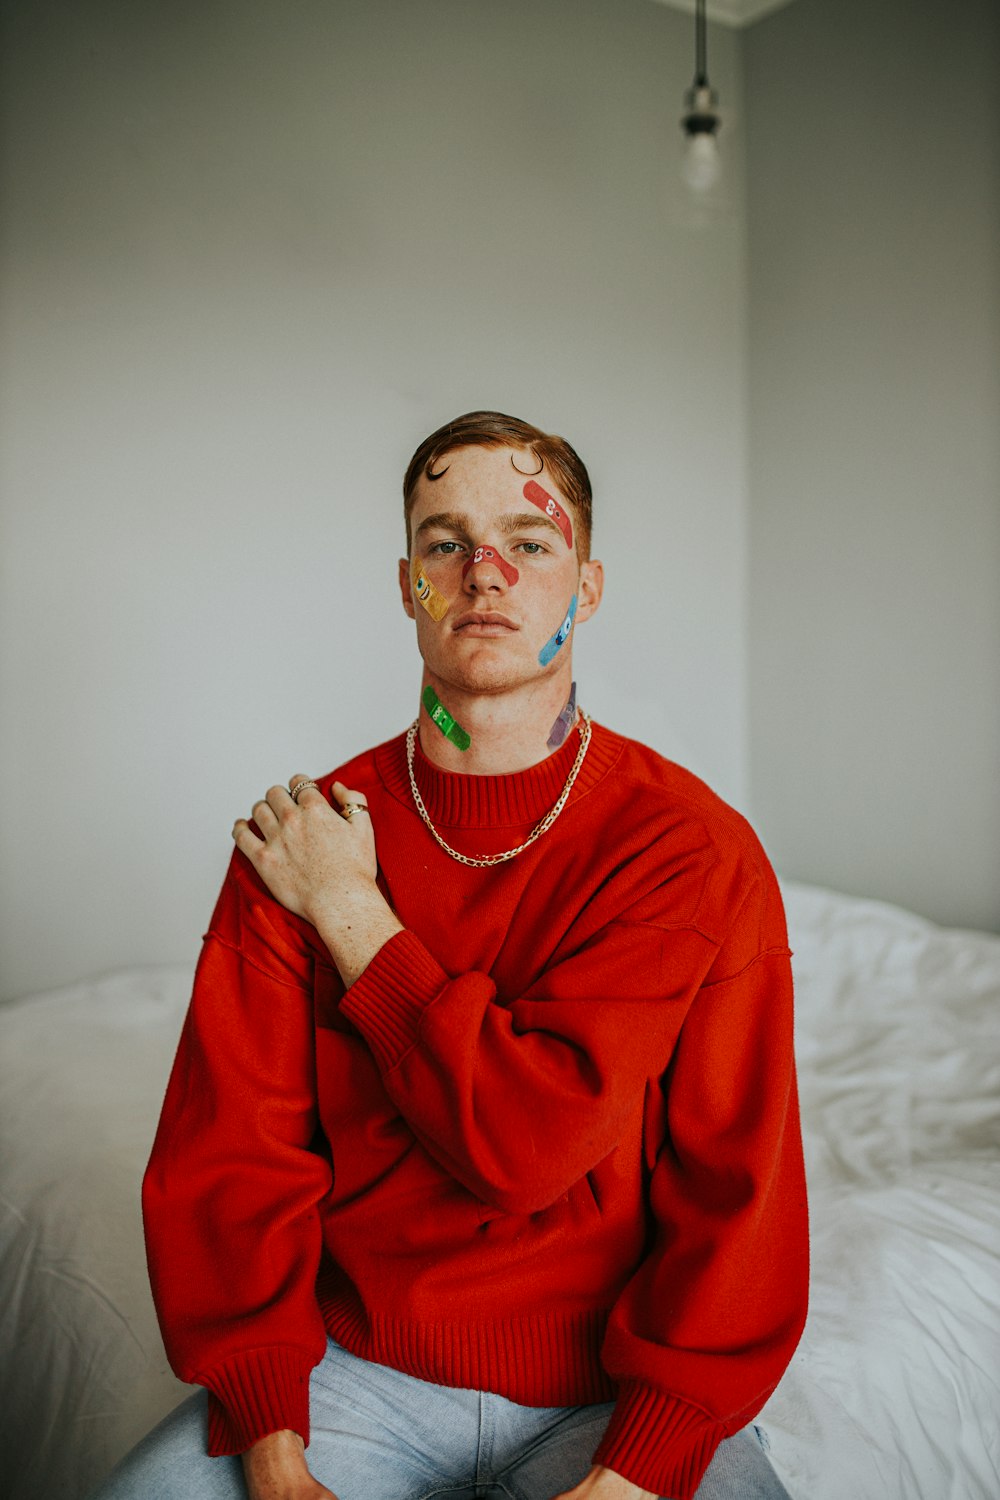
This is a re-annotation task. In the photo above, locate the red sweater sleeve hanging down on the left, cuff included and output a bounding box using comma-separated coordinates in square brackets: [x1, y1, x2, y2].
[142, 861, 330, 1455]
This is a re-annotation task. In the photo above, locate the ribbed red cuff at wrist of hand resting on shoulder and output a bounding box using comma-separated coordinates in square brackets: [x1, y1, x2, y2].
[340, 930, 448, 1073]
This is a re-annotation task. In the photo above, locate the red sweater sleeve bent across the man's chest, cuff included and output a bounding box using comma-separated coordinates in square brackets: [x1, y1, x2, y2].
[340, 923, 715, 1214]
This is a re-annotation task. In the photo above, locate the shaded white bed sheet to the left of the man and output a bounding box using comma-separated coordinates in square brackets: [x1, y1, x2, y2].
[0, 968, 190, 1500]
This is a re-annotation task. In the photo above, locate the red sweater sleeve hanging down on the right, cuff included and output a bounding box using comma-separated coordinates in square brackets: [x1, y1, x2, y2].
[595, 951, 808, 1500]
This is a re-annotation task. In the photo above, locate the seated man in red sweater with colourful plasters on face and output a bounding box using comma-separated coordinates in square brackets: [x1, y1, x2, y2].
[93, 413, 807, 1500]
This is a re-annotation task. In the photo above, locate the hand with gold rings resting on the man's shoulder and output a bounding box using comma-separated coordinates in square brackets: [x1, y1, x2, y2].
[232, 776, 376, 927]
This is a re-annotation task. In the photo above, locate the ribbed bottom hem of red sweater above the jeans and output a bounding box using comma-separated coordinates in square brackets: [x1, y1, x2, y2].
[319, 1289, 616, 1406]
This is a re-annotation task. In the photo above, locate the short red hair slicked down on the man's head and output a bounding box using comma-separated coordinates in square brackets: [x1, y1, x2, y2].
[403, 411, 594, 563]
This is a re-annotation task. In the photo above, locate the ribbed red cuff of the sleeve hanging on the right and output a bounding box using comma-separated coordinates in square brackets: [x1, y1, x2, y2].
[594, 1385, 727, 1500]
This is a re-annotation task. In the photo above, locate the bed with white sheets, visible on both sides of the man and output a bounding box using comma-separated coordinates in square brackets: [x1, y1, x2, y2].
[0, 882, 1000, 1500]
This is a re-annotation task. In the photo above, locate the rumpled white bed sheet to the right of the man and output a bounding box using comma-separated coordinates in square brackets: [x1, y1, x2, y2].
[760, 885, 1000, 1500]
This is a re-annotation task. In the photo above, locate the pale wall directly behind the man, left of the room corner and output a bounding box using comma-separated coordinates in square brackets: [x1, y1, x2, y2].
[0, 0, 747, 995]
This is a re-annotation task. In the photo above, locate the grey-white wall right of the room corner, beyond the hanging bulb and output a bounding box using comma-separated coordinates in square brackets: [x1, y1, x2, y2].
[745, 0, 1000, 927]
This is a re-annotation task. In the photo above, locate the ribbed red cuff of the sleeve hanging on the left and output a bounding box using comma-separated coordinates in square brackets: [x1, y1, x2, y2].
[198, 1349, 315, 1458]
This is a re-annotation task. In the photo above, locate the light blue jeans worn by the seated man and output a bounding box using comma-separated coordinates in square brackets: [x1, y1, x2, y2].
[90, 1341, 789, 1500]
